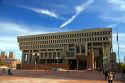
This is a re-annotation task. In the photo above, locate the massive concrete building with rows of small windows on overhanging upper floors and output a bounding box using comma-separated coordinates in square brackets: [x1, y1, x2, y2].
[17, 28, 112, 69]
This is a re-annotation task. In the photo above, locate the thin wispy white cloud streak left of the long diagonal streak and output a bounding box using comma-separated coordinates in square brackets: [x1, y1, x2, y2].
[18, 6, 64, 20]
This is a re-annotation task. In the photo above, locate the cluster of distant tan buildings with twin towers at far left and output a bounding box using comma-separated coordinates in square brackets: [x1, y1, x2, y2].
[0, 51, 20, 68]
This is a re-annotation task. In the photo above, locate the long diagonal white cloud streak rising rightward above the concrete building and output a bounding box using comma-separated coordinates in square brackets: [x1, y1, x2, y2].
[60, 0, 94, 28]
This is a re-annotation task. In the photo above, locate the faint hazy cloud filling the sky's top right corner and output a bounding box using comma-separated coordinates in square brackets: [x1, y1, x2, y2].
[100, 0, 125, 23]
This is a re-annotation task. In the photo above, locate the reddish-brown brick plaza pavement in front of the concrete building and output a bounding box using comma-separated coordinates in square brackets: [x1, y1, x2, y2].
[0, 70, 125, 83]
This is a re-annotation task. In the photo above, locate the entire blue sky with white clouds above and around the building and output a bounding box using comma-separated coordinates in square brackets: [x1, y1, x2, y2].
[0, 0, 125, 61]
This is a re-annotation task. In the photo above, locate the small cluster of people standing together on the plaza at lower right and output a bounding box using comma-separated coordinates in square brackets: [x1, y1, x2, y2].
[103, 70, 115, 83]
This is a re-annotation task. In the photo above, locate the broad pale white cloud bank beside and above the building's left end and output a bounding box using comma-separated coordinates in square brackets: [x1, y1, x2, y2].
[0, 21, 47, 58]
